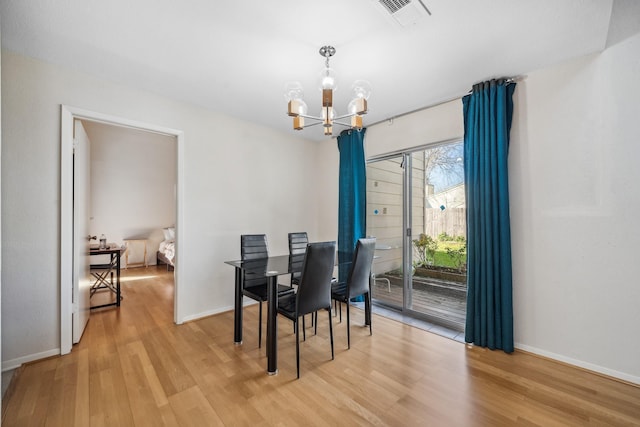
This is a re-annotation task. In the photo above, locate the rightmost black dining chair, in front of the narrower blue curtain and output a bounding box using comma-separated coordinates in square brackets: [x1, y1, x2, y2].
[331, 237, 376, 348]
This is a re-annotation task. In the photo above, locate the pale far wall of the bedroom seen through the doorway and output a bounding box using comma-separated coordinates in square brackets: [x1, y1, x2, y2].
[84, 122, 177, 265]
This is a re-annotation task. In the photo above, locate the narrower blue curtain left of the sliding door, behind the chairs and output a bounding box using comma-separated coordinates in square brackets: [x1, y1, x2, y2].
[338, 129, 367, 290]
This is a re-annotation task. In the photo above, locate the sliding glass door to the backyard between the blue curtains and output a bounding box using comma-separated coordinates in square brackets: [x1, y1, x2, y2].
[367, 141, 466, 330]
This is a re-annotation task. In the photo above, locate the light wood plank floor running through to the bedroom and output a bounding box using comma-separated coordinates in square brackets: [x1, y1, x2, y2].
[2, 267, 640, 426]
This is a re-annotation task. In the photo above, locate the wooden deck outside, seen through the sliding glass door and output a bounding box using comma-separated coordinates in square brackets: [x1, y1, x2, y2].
[373, 275, 467, 331]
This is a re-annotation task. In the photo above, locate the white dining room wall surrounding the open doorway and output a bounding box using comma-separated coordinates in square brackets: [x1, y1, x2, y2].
[2, 51, 337, 369]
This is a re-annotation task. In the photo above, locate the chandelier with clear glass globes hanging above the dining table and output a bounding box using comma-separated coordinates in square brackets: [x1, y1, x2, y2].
[285, 46, 371, 135]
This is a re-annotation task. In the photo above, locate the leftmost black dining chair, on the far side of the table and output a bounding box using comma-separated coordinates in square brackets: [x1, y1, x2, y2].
[240, 234, 293, 348]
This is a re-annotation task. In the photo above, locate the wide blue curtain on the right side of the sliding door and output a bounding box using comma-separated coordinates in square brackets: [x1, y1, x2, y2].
[462, 80, 516, 353]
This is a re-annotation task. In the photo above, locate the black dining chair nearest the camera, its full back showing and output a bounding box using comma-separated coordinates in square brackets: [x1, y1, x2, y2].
[278, 242, 336, 378]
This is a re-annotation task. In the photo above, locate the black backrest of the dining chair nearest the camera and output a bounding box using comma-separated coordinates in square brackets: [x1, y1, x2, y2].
[297, 242, 336, 316]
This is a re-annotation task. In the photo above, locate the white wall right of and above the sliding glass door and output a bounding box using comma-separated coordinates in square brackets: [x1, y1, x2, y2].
[366, 35, 640, 383]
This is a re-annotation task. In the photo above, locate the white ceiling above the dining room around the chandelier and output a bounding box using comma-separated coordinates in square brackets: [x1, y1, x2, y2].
[0, 0, 613, 140]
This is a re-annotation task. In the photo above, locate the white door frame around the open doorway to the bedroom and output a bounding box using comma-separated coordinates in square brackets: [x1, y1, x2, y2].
[60, 104, 184, 354]
